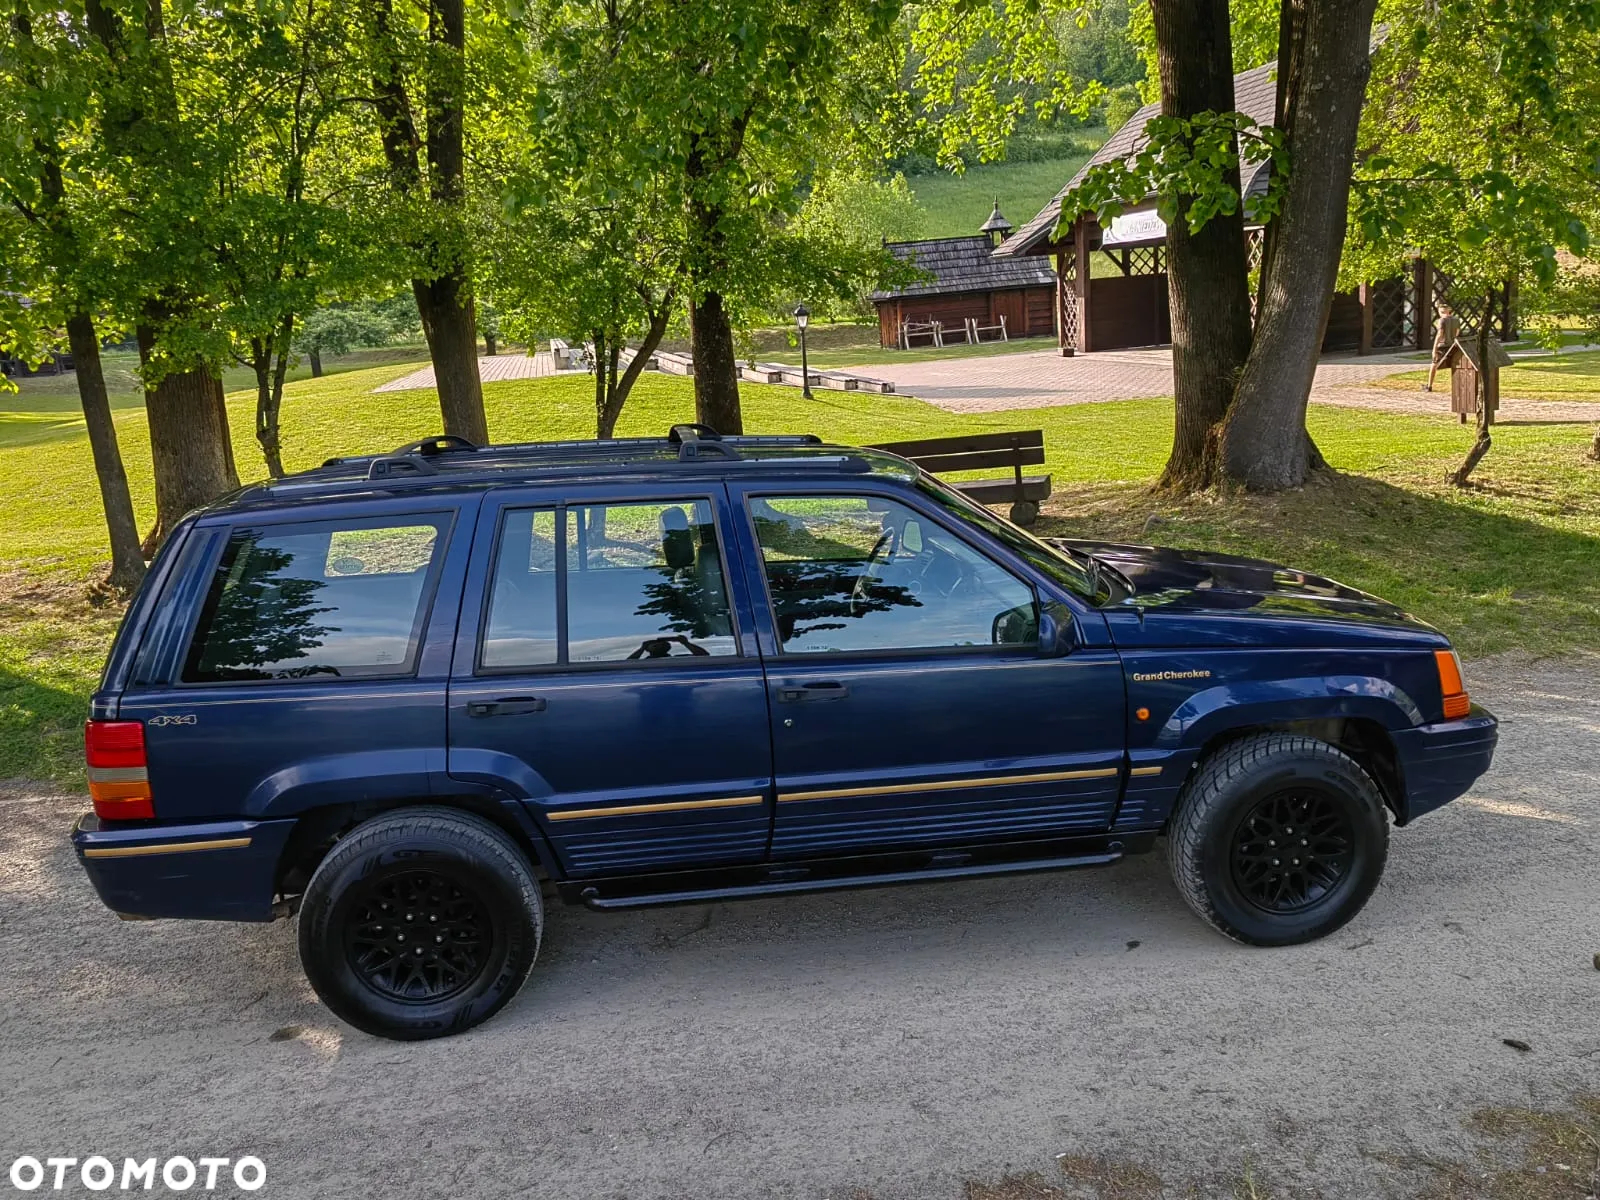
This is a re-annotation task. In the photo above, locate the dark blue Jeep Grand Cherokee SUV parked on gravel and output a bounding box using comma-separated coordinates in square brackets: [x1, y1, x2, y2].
[72, 426, 1496, 1038]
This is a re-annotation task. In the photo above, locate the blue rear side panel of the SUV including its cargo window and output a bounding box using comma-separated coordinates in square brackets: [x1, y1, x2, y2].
[118, 498, 477, 821]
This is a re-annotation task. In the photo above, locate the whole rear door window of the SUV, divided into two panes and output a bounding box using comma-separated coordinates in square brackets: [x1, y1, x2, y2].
[482, 499, 738, 670]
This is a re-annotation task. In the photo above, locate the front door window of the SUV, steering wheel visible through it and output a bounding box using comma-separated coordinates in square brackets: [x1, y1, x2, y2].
[750, 496, 1038, 653]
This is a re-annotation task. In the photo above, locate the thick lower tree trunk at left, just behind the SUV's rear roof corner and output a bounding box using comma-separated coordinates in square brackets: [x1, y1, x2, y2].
[138, 325, 238, 554]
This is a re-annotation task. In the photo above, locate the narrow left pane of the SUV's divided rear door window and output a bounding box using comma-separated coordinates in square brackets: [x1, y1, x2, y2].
[480, 509, 558, 667]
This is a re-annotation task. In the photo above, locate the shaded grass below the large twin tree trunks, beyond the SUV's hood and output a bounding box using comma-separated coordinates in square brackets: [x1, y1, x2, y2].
[1035, 475, 1600, 654]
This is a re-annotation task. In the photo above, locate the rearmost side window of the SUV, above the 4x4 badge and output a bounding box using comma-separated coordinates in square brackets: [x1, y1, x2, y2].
[184, 518, 443, 682]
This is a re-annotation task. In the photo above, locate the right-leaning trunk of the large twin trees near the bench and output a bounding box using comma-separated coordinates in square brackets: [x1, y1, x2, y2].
[1221, 0, 1376, 491]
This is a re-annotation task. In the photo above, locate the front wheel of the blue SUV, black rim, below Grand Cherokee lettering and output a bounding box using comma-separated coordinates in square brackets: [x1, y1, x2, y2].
[1166, 733, 1389, 946]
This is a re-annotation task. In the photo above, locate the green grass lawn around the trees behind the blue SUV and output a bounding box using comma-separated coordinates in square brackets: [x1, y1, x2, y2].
[0, 355, 1600, 781]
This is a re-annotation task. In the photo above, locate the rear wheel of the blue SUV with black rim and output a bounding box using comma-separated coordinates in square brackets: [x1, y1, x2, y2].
[299, 808, 544, 1042]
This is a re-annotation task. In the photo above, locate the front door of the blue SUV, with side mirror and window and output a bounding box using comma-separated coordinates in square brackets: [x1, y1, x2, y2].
[738, 488, 1125, 858]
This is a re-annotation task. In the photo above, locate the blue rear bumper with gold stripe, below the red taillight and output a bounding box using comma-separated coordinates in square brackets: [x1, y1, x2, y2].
[72, 813, 294, 922]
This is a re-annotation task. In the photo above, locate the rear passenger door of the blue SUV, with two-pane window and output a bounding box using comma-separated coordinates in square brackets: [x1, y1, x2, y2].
[450, 482, 771, 877]
